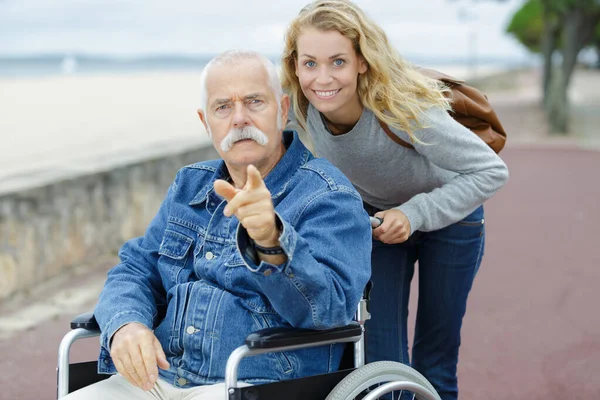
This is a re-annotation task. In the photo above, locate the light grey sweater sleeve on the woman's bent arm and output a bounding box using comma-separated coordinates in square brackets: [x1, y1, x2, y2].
[391, 108, 508, 234]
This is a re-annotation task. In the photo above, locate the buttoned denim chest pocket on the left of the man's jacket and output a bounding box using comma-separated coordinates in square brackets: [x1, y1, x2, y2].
[158, 228, 194, 283]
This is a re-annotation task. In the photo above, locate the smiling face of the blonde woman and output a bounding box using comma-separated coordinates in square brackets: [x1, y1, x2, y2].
[296, 28, 367, 121]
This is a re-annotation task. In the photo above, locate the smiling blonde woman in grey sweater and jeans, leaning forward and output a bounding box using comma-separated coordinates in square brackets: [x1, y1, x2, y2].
[282, 0, 508, 400]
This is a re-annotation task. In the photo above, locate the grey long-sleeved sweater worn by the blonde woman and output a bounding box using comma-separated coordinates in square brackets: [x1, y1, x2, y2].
[307, 105, 508, 233]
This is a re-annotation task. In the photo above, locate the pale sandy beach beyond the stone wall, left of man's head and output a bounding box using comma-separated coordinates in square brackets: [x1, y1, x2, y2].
[0, 71, 208, 194]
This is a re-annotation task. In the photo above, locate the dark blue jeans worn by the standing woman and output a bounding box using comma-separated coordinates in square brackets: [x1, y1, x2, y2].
[365, 205, 485, 400]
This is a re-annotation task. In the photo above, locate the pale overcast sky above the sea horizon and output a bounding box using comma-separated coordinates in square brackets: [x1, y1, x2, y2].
[0, 0, 527, 59]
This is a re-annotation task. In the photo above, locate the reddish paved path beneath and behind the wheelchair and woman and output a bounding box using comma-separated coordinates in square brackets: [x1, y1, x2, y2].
[0, 146, 600, 400]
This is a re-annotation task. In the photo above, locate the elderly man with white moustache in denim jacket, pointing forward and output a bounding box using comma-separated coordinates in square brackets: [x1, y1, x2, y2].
[61, 51, 371, 400]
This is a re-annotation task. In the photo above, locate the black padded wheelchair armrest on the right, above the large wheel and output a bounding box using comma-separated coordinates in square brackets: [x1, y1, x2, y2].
[246, 323, 362, 349]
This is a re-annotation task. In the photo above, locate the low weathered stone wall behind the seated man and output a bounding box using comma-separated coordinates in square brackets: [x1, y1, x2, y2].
[0, 145, 218, 304]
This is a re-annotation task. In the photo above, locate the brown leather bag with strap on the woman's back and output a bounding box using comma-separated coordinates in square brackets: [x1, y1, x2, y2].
[379, 68, 506, 153]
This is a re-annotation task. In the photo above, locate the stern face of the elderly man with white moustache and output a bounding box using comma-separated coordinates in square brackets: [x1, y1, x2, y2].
[199, 60, 289, 173]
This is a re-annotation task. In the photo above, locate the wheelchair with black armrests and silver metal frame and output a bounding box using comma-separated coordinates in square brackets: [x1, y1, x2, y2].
[57, 287, 441, 400]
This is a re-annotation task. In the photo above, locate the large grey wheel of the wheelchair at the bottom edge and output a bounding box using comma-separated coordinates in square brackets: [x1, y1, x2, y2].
[325, 361, 441, 400]
